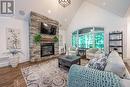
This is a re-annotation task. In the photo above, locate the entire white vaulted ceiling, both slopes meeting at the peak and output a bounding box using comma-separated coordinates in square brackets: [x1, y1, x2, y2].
[15, 0, 130, 29]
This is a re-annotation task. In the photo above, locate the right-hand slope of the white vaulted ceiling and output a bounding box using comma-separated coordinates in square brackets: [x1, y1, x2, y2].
[87, 0, 130, 17]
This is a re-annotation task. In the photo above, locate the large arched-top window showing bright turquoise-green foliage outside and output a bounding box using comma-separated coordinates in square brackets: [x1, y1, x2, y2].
[72, 27, 104, 49]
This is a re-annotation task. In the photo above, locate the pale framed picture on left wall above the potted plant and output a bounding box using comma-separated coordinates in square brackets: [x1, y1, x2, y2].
[6, 28, 21, 49]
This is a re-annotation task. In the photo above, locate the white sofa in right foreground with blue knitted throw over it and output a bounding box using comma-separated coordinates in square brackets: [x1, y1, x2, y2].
[68, 51, 130, 87]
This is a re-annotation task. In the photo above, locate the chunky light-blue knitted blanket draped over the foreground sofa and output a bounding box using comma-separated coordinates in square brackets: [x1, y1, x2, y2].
[68, 65, 121, 87]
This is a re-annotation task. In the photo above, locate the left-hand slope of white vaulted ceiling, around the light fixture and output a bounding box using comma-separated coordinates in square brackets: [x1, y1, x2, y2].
[15, 0, 83, 29]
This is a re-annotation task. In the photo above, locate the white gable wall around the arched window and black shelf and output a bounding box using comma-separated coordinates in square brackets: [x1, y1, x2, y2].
[66, 1, 127, 57]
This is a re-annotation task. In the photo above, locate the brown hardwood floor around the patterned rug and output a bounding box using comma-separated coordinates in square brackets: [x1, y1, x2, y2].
[0, 61, 130, 87]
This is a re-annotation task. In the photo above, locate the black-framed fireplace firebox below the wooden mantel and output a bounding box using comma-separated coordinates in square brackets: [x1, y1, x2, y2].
[41, 43, 54, 57]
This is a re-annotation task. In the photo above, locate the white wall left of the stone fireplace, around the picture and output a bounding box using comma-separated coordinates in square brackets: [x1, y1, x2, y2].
[0, 17, 29, 62]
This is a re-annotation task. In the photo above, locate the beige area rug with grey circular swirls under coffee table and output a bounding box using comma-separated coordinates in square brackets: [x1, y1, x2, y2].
[21, 59, 86, 87]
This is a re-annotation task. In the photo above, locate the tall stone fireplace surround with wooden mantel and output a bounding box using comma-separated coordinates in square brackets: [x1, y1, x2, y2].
[29, 12, 59, 62]
